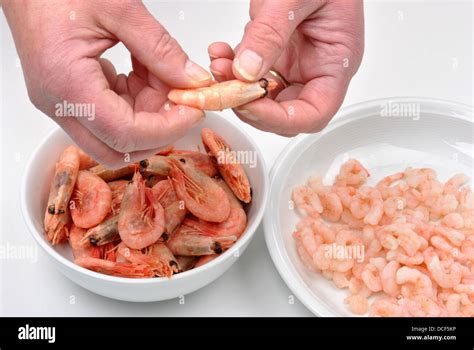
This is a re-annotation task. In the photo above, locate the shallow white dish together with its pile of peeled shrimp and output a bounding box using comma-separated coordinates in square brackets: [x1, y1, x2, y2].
[264, 98, 474, 317]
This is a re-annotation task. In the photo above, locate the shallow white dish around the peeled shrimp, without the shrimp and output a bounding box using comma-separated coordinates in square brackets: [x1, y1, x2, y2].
[264, 98, 474, 316]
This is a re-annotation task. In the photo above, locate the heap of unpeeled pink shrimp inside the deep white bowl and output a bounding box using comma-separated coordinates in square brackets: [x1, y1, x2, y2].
[44, 128, 252, 278]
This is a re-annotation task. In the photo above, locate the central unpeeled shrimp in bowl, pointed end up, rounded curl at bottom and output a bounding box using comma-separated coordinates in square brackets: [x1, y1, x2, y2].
[118, 172, 165, 249]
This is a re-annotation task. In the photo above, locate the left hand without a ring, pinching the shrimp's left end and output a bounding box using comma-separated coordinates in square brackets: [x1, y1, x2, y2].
[2, 0, 212, 167]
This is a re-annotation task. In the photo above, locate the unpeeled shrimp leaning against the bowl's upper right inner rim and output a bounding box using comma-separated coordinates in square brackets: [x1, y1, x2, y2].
[201, 128, 252, 203]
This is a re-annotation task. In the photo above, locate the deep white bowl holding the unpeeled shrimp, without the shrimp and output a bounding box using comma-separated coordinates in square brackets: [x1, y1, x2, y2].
[21, 113, 268, 302]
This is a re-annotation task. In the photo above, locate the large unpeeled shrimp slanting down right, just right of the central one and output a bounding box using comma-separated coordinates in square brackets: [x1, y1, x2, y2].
[170, 160, 230, 222]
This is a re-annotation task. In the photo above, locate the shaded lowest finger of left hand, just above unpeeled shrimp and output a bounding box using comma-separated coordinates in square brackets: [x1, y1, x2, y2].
[52, 118, 164, 169]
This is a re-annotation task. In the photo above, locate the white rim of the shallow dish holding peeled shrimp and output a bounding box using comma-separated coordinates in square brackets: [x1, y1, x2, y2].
[263, 96, 474, 317]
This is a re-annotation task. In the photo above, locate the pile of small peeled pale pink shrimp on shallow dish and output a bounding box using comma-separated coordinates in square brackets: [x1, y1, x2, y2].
[292, 159, 474, 317]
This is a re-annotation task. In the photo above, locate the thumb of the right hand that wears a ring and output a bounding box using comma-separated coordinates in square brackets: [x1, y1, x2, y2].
[232, 0, 316, 81]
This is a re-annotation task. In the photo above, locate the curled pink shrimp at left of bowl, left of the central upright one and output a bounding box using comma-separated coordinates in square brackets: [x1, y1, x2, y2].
[70, 170, 112, 228]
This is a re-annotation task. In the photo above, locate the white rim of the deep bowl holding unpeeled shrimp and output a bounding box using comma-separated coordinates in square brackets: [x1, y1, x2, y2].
[20, 112, 269, 285]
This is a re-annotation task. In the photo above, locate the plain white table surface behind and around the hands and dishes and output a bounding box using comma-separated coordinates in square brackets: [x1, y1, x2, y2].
[0, 0, 474, 316]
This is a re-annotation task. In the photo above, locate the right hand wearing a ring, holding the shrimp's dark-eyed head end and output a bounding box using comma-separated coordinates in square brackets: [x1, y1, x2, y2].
[208, 0, 364, 136]
